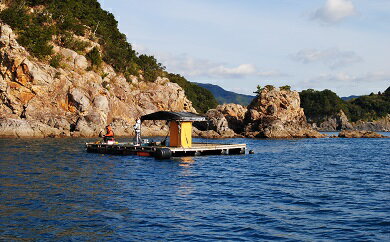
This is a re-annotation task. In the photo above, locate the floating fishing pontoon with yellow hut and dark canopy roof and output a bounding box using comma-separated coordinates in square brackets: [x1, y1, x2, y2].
[86, 111, 246, 159]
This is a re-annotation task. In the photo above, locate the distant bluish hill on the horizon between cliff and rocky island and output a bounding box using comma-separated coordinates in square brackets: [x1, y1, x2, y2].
[194, 82, 255, 106]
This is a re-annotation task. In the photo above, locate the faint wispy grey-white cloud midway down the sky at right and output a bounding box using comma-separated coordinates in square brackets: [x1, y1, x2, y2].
[291, 48, 363, 69]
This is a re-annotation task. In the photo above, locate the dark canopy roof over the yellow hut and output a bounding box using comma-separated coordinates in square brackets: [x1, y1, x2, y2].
[141, 111, 206, 121]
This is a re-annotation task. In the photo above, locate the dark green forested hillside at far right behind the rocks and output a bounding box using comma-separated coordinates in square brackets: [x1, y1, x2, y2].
[300, 87, 390, 122]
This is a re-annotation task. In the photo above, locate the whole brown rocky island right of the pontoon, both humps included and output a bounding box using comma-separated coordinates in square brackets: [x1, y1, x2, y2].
[200, 87, 325, 138]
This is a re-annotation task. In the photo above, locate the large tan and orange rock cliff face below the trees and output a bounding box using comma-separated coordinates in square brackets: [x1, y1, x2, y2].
[0, 24, 195, 137]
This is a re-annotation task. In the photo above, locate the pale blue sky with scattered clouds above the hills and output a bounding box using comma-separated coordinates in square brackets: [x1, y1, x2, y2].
[98, 0, 390, 96]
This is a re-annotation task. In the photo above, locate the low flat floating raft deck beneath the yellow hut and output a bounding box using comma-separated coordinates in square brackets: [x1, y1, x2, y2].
[86, 143, 246, 159]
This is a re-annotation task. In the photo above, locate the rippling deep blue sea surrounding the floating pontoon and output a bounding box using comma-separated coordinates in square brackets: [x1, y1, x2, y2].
[0, 139, 390, 241]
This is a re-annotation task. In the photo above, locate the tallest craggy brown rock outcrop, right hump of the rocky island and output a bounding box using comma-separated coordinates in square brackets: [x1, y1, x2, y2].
[245, 88, 324, 138]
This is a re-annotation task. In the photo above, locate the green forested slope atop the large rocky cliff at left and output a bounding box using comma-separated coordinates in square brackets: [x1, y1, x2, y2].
[0, 0, 216, 112]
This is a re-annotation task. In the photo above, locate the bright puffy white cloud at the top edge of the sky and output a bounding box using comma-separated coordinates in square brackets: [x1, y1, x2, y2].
[313, 0, 356, 24]
